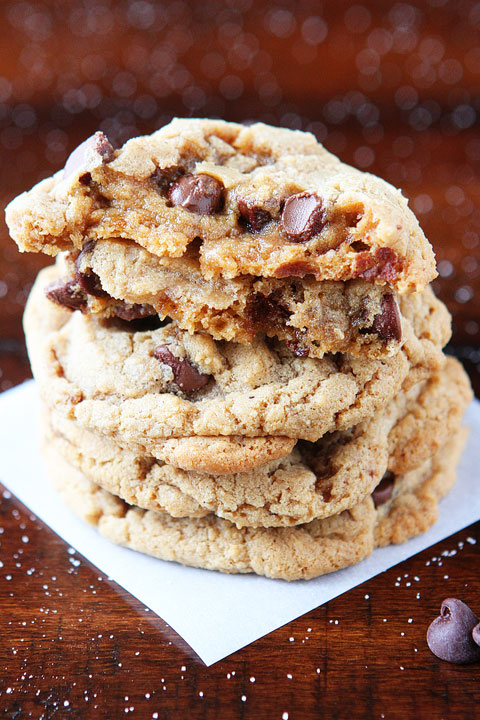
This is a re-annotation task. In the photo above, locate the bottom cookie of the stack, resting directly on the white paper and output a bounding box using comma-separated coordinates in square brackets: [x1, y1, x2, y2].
[42, 433, 464, 580]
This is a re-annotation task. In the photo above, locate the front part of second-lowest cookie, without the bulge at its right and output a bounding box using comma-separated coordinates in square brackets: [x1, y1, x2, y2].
[44, 404, 388, 527]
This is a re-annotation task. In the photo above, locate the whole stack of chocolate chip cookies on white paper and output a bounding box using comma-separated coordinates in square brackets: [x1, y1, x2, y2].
[7, 120, 471, 580]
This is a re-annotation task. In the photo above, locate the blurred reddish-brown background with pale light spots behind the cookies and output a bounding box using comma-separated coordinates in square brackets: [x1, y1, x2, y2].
[0, 0, 480, 390]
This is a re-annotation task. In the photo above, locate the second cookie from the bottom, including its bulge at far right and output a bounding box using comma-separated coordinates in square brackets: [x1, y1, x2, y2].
[43, 358, 471, 527]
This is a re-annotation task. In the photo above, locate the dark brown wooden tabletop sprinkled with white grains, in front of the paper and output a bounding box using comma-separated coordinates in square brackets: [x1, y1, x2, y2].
[0, 484, 480, 720]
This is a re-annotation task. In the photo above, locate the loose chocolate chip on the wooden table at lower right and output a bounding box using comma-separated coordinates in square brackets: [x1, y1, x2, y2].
[427, 598, 480, 665]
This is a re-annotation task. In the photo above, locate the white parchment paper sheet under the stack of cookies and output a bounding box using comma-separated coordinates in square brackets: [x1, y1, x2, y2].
[0, 381, 480, 665]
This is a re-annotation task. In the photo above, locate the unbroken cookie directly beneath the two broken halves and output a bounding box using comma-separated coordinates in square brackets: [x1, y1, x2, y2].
[25, 268, 450, 450]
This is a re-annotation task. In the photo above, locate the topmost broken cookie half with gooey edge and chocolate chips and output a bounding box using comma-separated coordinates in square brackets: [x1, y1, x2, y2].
[7, 119, 435, 292]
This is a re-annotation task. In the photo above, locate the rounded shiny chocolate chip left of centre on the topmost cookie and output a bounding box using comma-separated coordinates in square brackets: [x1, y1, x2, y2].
[168, 175, 224, 215]
